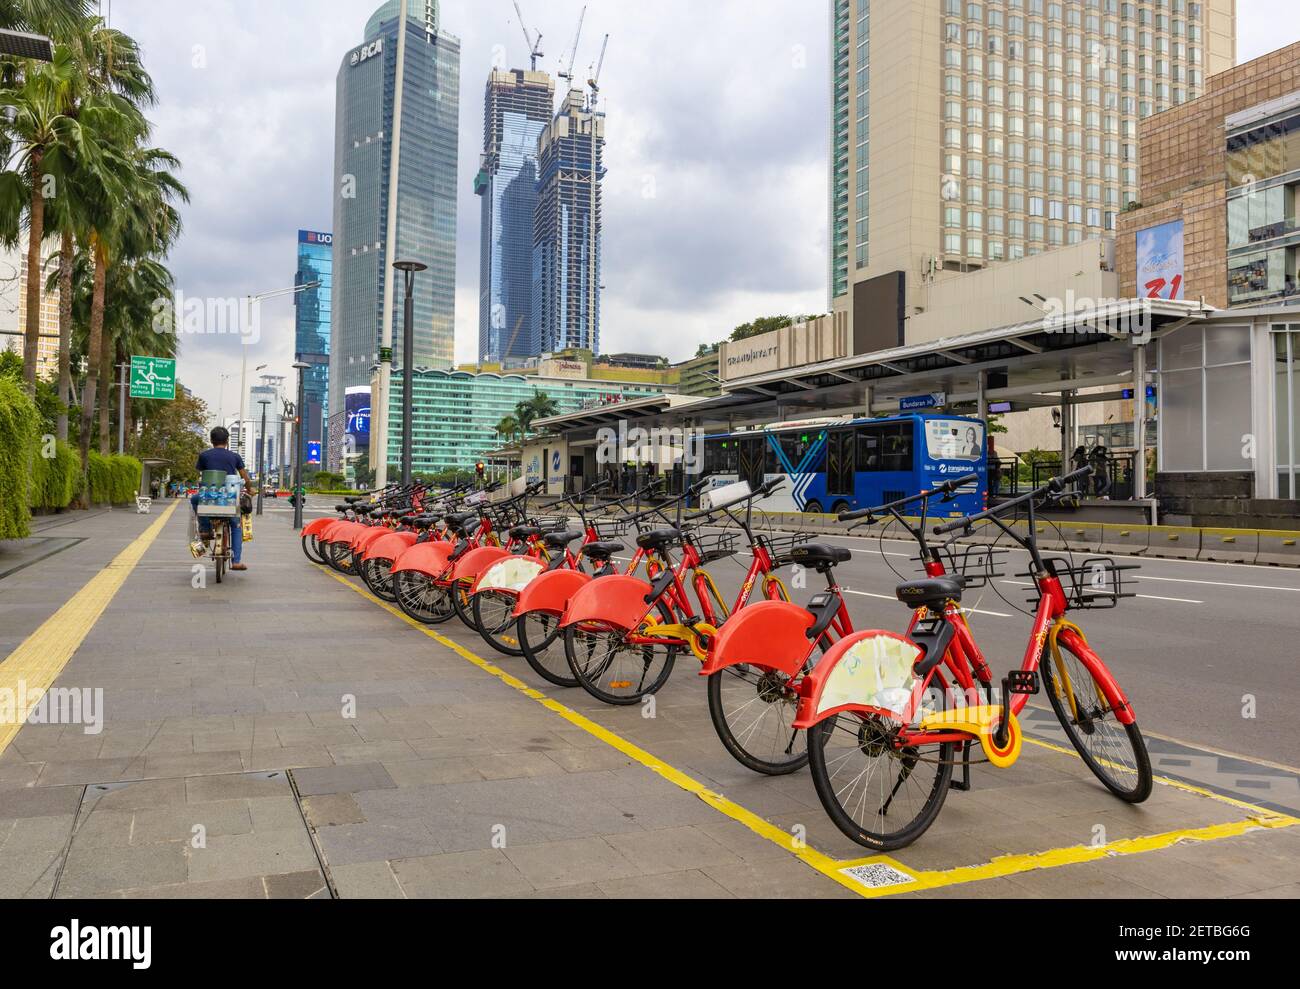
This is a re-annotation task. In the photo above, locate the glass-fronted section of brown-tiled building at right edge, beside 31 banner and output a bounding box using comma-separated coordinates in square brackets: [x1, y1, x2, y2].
[1227, 105, 1300, 305]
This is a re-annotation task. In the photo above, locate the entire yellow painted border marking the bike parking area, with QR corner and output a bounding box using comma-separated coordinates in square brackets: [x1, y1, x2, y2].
[316, 564, 1300, 898]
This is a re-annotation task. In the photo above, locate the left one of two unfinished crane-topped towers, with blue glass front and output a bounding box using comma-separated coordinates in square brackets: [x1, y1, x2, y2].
[475, 69, 555, 361]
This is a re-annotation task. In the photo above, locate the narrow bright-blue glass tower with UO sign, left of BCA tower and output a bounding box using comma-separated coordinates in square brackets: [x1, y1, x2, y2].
[294, 230, 334, 443]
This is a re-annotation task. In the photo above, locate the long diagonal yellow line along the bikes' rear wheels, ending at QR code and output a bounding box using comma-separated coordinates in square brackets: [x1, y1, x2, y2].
[317, 564, 870, 895]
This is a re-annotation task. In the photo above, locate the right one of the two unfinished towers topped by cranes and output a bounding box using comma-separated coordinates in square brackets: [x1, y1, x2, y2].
[533, 90, 605, 353]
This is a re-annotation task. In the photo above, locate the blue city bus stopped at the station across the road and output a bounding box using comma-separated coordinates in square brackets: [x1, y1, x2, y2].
[703, 413, 988, 516]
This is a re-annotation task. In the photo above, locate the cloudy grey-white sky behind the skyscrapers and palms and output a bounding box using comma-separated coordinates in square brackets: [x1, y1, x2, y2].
[103, 0, 1300, 415]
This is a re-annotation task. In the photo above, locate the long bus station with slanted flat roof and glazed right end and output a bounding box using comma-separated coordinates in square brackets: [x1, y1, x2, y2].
[520, 300, 1300, 528]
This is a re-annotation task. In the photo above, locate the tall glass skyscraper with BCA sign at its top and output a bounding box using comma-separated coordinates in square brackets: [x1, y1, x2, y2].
[329, 0, 460, 467]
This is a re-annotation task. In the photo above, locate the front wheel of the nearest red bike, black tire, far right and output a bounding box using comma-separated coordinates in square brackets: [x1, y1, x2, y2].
[1039, 631, 1153, 803]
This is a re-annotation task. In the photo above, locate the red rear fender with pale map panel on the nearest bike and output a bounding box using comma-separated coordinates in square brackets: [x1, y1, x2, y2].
[790, 629, 924, 728]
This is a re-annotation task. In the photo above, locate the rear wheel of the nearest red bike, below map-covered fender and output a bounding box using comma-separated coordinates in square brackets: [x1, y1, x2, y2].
[807, 712, 956, 851]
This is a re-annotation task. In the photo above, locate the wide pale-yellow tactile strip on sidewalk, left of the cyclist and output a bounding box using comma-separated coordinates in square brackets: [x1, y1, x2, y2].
[0, 502, 178, 752]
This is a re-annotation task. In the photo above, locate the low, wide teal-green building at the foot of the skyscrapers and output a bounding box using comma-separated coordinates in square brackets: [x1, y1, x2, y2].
[389, 369, 663, 473]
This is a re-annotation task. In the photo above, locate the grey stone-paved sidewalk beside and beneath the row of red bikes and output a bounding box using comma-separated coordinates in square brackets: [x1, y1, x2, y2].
[0, 503, 1300, 897]
